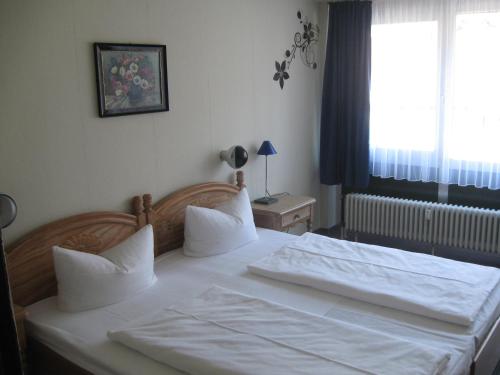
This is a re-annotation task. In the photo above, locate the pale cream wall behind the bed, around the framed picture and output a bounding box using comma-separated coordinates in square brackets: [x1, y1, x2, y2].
[0, 0, 324, 242]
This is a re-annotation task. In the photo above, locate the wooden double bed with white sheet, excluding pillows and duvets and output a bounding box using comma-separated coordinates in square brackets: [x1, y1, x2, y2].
[7, 174, 500, 375]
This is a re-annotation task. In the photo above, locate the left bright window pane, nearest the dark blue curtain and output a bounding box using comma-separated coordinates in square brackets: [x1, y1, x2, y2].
[370, 21, 438, 152]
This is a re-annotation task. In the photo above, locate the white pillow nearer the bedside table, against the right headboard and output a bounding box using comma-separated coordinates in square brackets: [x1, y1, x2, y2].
[184, 189, 259, 257]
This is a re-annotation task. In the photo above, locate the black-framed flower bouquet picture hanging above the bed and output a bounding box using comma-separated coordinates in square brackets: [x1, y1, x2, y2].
[94, 43, 169, 117]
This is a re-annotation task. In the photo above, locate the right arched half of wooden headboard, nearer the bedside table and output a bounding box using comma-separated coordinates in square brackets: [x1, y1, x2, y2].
[144, 171, 245, 256]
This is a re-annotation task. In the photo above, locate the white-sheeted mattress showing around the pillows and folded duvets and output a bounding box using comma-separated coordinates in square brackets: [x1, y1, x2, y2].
[26, 229, 500, 375]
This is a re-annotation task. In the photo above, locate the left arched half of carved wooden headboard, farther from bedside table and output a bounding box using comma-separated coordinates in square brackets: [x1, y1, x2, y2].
[6, 197, 146, 306]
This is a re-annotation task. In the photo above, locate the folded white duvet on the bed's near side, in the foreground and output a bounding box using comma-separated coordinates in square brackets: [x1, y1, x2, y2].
[108, 287, 450, 375]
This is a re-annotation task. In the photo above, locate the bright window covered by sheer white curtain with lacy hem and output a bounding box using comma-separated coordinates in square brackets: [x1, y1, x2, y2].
[370, 0, 500, 189]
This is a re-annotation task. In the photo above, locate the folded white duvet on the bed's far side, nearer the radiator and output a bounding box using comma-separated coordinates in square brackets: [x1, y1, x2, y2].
[248, 233, 500, 326]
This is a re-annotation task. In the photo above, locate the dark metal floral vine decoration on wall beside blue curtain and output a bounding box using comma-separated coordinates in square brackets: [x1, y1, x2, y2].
[273, 10, 319, 90]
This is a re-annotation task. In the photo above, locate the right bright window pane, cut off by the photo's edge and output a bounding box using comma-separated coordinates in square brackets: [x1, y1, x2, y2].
[444, 13, 500, 163]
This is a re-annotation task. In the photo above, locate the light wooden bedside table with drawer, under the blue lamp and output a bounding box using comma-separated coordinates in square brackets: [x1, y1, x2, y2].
[252, 195, 316, 232]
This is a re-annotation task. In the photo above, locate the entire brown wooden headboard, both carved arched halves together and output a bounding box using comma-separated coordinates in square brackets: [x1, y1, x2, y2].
[6, 171, 244, 306]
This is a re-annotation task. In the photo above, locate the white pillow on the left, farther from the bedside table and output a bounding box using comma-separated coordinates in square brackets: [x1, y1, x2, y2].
[53, 225, 156, 312]
